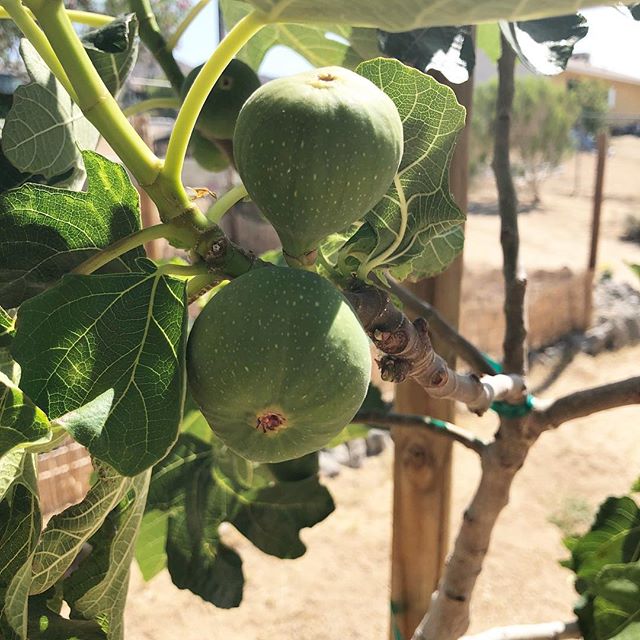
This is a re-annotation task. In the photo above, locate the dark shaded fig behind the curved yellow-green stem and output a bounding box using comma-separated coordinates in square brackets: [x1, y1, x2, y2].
[182, 59, 260, 140]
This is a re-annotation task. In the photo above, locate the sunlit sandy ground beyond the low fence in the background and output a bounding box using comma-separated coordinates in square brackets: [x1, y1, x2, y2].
[464, 136, 640, 281]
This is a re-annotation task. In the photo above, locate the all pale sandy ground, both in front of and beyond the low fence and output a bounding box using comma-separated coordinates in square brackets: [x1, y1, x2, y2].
[126, 137, 640, 640]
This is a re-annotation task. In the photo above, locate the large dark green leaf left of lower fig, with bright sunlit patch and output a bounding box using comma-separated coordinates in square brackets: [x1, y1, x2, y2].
[12, 271, 187, 476]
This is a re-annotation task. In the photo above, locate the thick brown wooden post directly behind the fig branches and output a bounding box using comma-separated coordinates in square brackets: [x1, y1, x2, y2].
[391, 74, 473, 640]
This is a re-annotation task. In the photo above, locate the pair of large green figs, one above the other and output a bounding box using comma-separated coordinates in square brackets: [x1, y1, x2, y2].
[187, 67, 403, 463]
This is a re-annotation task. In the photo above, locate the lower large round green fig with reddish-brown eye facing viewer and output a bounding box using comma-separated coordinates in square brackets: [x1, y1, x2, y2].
[187, 267, 371, 462]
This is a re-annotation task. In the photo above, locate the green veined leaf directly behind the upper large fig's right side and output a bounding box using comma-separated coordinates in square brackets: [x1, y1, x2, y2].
[337, 58, 465, 280]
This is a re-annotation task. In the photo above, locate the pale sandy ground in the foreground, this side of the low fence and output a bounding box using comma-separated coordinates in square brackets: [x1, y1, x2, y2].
[126, 347, 640, 640]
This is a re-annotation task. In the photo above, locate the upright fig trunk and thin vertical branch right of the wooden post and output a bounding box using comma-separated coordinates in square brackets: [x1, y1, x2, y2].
[413, 35, 535, 640]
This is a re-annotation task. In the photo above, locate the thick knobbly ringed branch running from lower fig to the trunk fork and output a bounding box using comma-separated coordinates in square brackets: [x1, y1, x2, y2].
[345, 285, 525, 415]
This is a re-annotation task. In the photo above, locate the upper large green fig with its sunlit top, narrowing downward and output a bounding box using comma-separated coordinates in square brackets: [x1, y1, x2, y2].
[233, 67, 403, 262]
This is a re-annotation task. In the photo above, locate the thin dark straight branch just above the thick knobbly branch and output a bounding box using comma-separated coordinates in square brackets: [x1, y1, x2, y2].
[389, 280, 495, 375]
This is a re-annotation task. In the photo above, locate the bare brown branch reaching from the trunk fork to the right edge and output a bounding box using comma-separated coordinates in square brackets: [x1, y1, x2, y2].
[529, 376, 640, 433]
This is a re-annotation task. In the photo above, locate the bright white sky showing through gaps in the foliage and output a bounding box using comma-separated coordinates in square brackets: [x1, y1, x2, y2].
[176, 2, 640, 78]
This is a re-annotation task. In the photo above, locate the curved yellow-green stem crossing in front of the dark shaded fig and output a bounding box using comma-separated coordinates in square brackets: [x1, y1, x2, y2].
[162, 10, 267, 190]
